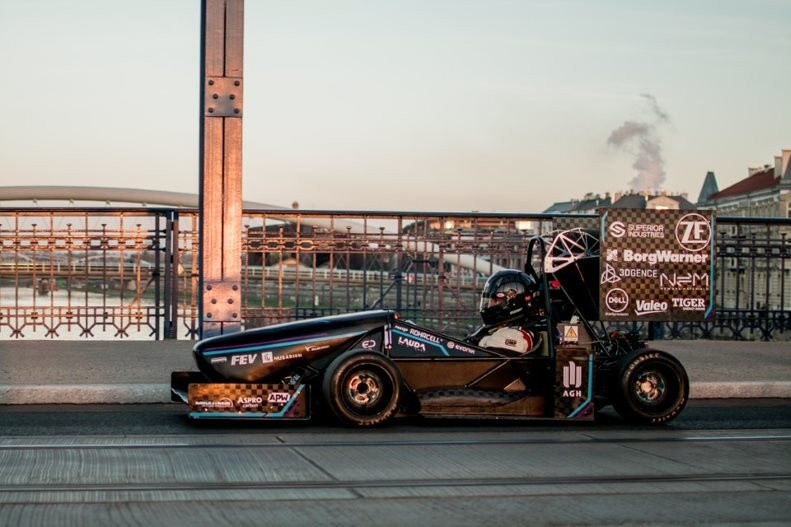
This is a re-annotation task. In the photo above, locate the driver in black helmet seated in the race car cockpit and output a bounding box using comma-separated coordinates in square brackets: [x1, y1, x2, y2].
[466, 269, 540, 354]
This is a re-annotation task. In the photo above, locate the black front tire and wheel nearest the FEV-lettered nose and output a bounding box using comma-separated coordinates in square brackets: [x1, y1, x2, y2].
[322, 352, 402, 427]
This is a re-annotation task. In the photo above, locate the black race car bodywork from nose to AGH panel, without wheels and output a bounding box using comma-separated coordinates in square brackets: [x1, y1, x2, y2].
[171, 311, 593, 420]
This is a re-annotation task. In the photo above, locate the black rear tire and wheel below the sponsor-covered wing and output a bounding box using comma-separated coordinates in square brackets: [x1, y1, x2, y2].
[611, 349, 689, 425]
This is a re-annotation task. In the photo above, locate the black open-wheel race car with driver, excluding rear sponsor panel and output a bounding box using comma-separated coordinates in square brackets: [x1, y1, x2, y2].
[171, 229, 689, 427]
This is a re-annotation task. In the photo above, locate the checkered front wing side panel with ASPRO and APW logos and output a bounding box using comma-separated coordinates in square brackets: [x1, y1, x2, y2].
[189, 383, 308, 419]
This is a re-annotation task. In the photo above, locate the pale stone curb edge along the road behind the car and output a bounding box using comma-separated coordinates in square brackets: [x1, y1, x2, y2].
[0, 381, 791, 405]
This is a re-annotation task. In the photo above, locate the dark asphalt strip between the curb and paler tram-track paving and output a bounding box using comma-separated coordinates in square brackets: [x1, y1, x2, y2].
[0, 399, 791, 438]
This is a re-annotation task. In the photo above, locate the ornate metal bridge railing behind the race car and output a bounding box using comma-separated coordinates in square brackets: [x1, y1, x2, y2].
[0, 208, 791, 340]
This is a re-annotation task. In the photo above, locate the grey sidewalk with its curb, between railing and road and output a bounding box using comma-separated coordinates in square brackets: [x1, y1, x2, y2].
[0, 340, 791, 404]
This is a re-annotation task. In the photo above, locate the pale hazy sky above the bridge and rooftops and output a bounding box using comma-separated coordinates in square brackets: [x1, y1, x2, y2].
[0, 0, 791, 213]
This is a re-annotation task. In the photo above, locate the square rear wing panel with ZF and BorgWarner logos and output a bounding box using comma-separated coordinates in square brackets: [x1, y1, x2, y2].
[599, 209, 715, 321]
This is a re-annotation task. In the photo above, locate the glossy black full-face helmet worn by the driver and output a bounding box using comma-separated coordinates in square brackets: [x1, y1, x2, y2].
[480, 269, 538, 326]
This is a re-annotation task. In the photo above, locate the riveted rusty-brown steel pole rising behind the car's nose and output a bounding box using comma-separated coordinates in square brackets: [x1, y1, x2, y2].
[199, 0, 244, 338]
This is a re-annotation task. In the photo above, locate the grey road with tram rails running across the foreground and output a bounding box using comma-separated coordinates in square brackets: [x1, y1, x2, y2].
[0, 400, 791, 527]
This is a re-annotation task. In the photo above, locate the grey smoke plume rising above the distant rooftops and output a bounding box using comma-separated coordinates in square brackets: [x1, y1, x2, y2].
[607, 93, 670, 191]
